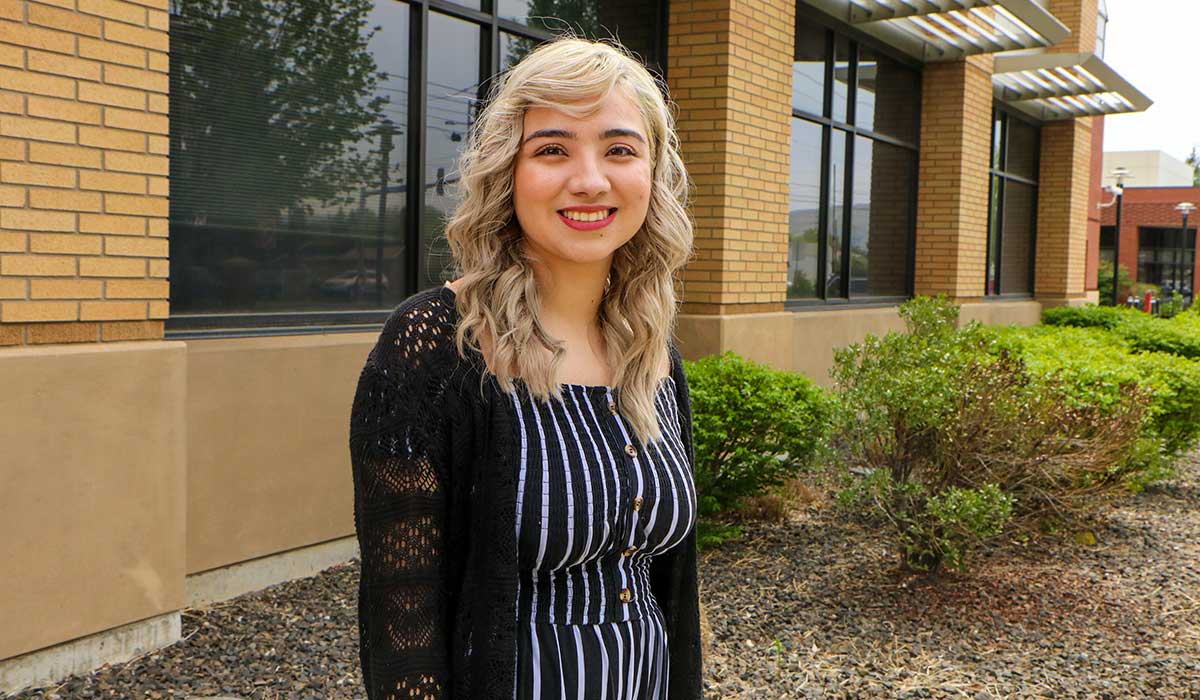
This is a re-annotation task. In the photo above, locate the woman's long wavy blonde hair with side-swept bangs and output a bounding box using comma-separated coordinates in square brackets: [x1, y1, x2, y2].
[446, 37, 692, 443]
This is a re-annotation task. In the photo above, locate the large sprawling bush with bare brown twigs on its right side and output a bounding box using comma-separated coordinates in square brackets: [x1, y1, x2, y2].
[830, 298, 1147, 570]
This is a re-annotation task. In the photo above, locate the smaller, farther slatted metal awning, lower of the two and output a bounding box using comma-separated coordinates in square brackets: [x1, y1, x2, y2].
[991, 52, 1153, 121]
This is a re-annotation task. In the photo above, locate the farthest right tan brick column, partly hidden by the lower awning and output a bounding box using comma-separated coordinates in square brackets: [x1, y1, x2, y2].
[1034, 0, 1098, 305]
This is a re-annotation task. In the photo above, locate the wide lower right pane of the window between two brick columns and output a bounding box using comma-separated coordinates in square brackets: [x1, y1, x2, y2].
[850, 137, 914, 298]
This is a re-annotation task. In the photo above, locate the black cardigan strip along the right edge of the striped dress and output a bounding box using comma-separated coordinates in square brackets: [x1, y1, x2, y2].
[650, 343, 703, 700]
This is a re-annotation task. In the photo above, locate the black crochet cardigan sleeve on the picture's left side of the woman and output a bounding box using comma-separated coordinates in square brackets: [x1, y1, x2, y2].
[349, 305, 450, 700]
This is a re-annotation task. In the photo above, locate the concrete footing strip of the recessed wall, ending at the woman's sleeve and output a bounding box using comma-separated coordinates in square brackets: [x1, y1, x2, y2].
[185, 537, 359, 608]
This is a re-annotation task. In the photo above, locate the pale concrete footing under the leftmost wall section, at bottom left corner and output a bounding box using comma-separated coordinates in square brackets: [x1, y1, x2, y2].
[0, 611, 182, 695]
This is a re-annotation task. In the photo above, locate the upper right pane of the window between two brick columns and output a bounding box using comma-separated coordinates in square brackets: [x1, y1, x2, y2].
[854, 47, 920, 143]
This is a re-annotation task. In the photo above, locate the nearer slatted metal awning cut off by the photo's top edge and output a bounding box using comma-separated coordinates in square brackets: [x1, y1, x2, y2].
[804, 0, 1070, 62]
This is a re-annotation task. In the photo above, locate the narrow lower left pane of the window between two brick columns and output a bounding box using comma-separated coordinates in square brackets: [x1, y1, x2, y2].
[787, 119, 821, 299]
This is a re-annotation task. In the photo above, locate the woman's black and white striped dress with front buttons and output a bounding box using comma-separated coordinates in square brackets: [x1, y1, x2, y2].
[509, 377, 696, 700]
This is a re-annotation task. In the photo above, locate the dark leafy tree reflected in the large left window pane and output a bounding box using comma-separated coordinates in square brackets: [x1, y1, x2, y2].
[170, 0, 385, 227]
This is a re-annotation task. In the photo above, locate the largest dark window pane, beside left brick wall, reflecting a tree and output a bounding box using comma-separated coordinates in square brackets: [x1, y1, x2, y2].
[169, 0, 409, 313]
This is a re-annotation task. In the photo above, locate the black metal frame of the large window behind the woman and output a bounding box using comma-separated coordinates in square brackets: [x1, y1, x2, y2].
[164, 0, 668, 340]
